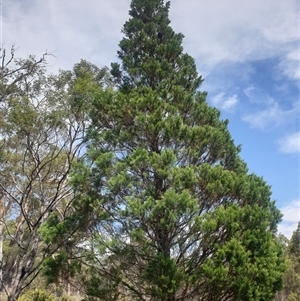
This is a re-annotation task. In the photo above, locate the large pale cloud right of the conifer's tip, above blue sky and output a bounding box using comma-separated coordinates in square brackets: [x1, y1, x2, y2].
[171, 0, 299, 76]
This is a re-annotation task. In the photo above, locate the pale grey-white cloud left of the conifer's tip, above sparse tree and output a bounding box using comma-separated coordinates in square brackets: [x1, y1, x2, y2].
[1, 0, 130, 70]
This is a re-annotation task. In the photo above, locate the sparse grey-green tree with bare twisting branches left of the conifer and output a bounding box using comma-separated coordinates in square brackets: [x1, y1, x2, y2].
[0, 46, 106, 300]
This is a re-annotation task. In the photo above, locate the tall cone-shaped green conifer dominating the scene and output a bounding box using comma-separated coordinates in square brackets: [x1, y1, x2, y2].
[66, 0, 284, 301]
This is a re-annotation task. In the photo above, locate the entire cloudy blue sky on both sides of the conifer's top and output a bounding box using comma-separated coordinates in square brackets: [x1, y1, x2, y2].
[0, 0, 300, 237]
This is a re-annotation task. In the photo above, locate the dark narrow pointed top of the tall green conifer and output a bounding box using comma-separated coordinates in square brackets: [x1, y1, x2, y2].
[111, 0, 202, 93]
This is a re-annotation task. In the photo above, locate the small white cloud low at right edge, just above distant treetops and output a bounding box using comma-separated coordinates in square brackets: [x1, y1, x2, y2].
[278, 200, 300, 239]
